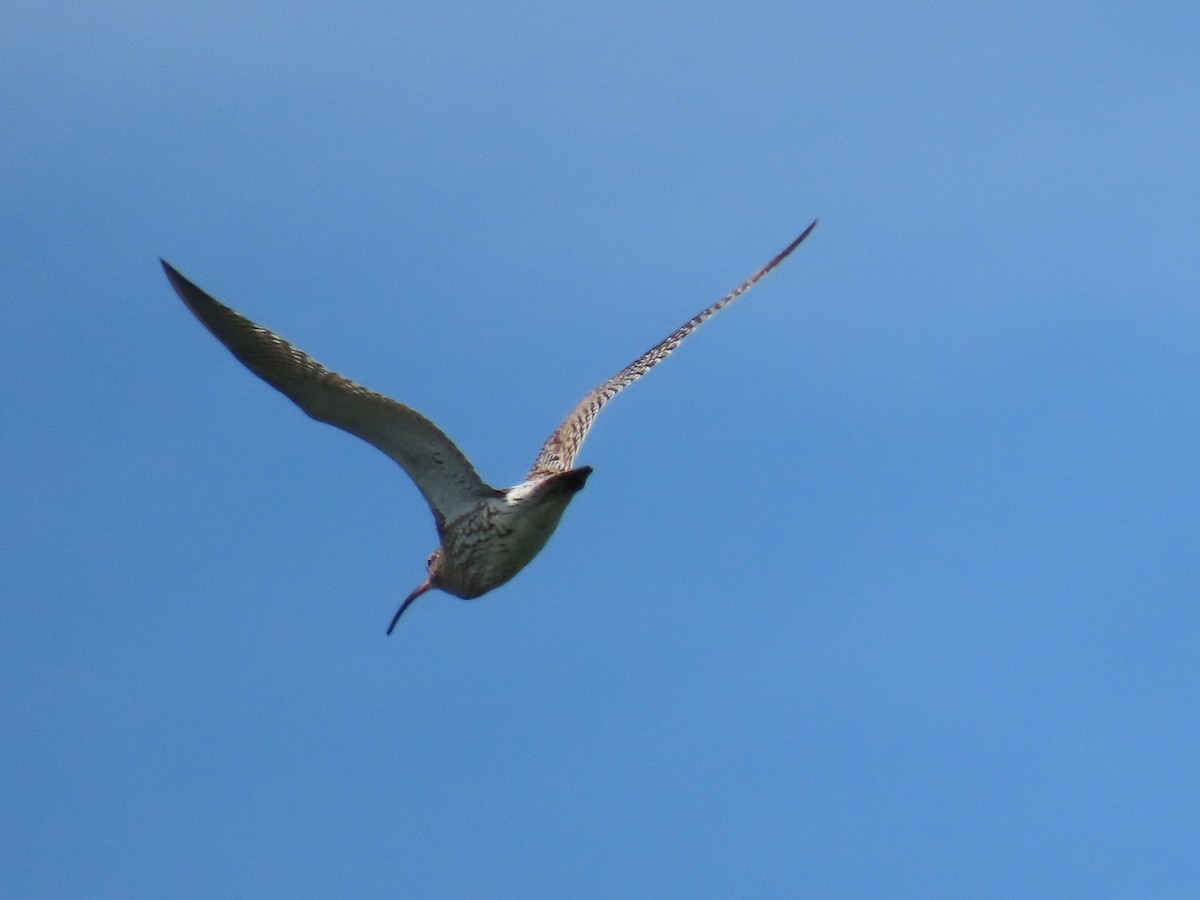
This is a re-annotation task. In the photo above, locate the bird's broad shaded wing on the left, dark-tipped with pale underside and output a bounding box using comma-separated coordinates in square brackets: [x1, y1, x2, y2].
[162, 262, 499, 535]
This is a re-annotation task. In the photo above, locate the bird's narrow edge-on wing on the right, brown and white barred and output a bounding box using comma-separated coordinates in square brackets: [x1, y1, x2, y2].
[527, 220, 817, 479]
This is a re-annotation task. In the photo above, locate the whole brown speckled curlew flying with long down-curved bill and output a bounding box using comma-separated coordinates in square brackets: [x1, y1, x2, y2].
[161, 221, 817, 635]
